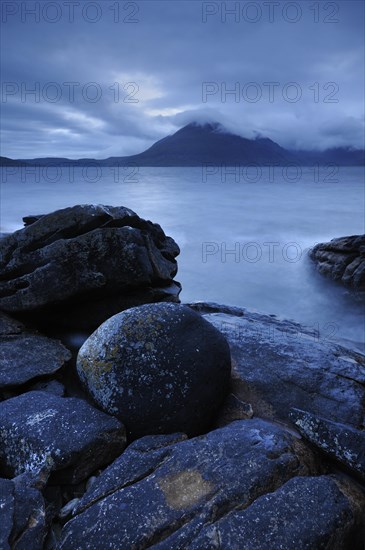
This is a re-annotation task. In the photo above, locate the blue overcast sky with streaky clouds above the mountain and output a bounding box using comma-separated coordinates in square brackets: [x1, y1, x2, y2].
[1, 0, 365, 159]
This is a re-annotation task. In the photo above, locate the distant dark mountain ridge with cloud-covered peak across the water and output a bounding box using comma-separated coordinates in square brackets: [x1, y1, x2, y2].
[0, 122, 365, 166]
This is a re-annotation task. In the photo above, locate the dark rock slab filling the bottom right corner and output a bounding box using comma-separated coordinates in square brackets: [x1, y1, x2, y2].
[188, 476, 365, 550]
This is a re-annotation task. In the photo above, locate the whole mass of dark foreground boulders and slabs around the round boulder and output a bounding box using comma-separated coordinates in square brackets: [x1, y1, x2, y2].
[0, 206, 365, 550]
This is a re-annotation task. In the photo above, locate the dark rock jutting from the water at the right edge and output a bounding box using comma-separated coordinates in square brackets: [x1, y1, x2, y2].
[309, 235, 365, 292]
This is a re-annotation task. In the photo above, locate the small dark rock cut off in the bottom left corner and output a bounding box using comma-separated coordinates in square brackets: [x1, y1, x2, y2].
[0, 477, 47, 550]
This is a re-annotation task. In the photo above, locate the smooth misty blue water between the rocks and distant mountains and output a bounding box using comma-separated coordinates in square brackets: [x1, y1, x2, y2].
[0, 167, 365, 342]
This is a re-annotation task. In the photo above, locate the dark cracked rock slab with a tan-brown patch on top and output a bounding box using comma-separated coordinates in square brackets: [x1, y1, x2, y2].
[59, 419, 316, 550]
